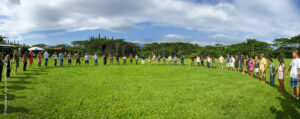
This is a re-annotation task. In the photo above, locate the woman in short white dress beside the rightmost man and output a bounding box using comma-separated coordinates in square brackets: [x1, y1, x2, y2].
[275, 57, 287, 93]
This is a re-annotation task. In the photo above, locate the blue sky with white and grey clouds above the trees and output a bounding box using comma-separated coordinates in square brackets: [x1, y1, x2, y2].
[0, 0, 300, 46]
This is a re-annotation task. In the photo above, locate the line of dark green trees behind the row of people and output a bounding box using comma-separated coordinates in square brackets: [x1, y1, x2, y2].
[0, 34, 300, 58]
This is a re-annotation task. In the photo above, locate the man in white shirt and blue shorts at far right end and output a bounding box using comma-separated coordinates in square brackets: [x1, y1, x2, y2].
[288, 50, 300, 101]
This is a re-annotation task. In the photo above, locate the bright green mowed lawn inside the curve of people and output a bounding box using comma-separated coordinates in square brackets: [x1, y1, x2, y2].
[0, 59, 300, 119]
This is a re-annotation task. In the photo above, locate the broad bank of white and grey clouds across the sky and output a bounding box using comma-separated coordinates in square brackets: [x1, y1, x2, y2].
[0, 0, 300, 42]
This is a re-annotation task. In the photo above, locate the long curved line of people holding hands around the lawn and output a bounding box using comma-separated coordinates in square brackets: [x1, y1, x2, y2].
[0, 50, 300, 100]
